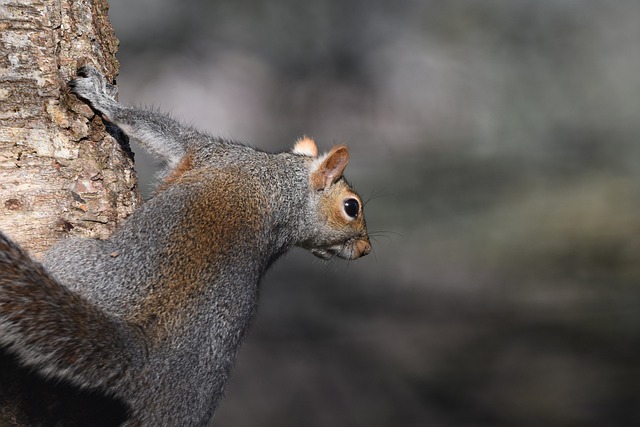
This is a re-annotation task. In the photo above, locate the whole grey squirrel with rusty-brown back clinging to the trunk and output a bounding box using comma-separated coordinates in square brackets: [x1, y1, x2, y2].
[0, 66, 371, 426]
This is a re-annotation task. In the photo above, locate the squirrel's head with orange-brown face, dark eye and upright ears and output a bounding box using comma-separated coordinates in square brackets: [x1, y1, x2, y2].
[292, 137, 371, 259]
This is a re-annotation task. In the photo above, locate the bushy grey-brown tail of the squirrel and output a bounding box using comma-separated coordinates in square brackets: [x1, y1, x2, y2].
[0, 232, 146, 397]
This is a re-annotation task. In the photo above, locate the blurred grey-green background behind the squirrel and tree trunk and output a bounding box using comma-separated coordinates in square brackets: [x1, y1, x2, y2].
[110, 0, 640, 427]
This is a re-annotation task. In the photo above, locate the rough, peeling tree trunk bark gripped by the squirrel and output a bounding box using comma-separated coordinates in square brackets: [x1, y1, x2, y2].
[0, 0, 140, 256]
